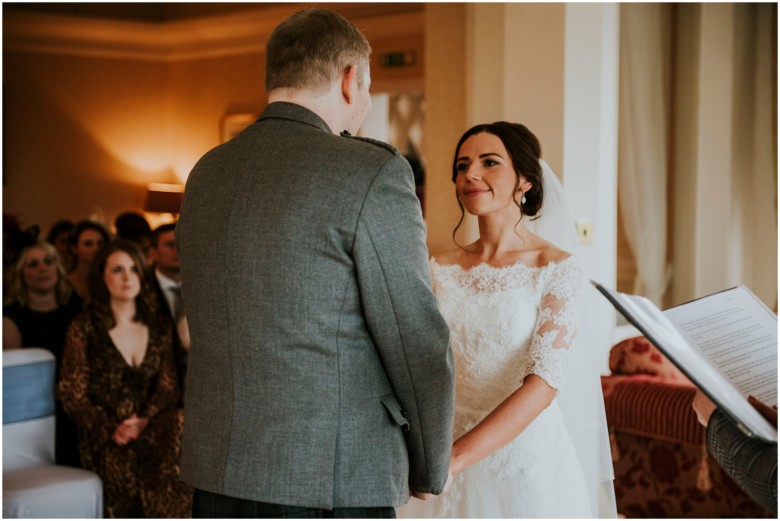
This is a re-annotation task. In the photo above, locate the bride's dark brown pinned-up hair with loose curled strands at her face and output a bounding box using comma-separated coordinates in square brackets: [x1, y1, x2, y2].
[452, 121, 544, 244]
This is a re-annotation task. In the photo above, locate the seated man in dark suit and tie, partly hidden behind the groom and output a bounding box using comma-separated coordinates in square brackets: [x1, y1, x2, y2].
[149, 223, 190, 398]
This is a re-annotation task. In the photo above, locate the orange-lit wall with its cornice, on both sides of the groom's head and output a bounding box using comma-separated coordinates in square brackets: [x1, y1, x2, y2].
[3, 4, 425, 234]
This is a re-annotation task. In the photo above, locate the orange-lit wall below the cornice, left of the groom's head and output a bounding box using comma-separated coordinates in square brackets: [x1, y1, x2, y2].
[3, 52, 264, 233]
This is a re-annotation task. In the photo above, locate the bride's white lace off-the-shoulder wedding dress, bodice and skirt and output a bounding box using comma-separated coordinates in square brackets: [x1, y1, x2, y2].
[398, 256, 592, 518]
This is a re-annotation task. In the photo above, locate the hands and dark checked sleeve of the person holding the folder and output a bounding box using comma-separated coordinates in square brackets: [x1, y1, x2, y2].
[693, 391, 777, 515]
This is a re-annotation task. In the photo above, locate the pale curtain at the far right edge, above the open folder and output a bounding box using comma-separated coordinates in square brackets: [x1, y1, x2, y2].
[729, 4, 777, 310]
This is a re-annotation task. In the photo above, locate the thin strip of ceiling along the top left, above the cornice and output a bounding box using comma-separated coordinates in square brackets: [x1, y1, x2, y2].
[3, 2, 423, 23]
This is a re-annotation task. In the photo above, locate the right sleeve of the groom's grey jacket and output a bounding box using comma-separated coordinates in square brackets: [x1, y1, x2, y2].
[353, 154, 454, 494]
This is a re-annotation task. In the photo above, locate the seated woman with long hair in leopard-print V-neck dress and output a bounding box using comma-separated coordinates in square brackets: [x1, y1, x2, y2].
[58, 239, 192, 518]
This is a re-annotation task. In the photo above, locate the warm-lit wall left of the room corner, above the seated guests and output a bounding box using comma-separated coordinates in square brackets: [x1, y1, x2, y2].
[3, 52, 171, 233]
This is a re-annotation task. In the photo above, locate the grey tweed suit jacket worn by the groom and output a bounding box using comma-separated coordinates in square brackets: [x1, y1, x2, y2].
[176, 103, 454, 508]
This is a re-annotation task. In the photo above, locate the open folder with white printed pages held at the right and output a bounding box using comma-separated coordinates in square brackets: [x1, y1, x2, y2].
[593, 282, 777, 441]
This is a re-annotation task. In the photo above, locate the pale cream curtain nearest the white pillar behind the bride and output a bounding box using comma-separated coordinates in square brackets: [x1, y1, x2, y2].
[618, 4, 671, 306]
